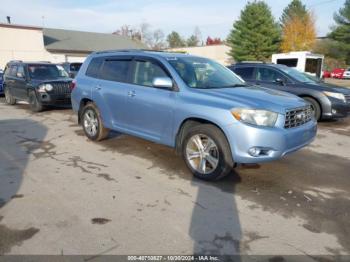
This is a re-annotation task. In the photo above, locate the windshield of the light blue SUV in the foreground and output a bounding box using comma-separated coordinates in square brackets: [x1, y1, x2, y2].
[167, 57, 245, 89]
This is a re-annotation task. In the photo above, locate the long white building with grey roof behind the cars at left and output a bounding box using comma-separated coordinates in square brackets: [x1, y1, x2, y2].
[0, 23, 147, 69]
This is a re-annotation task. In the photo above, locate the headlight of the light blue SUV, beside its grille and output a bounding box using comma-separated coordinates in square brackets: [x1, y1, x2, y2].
[231, 108, 278, 127]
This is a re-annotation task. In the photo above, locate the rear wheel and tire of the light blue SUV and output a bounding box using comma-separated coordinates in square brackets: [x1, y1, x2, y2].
[81, 102, 109, 141]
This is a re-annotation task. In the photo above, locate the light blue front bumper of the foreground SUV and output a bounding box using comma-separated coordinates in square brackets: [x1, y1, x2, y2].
[226, 120, 317, 164]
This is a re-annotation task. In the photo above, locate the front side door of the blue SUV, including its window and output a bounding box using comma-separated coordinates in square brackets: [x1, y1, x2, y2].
[125, 57, 177, 144]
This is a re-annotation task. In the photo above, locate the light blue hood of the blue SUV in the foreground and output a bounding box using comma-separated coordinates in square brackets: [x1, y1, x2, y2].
[196, 86, 306, 114]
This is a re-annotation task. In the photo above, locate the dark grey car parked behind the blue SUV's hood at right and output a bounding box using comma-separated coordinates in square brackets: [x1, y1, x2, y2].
[229, 63, 350, 120]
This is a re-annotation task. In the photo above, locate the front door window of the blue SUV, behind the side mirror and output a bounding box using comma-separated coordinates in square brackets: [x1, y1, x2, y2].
[132, 60, 169, 86]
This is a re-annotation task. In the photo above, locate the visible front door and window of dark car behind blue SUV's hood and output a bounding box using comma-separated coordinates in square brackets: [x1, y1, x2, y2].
[256, 67, 291, 92]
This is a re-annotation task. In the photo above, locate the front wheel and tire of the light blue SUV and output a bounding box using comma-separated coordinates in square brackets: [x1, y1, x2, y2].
[182, 124, 234, 181]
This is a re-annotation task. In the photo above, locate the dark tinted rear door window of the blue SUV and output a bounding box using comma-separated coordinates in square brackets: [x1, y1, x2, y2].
[100, 59, 131, 82]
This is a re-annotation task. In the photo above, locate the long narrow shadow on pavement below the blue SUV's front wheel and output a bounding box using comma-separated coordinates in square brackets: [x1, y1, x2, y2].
[189, 171, 242, 261]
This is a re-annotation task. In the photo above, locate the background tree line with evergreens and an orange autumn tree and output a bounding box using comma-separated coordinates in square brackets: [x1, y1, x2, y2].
[114, 0, 350, 67]
